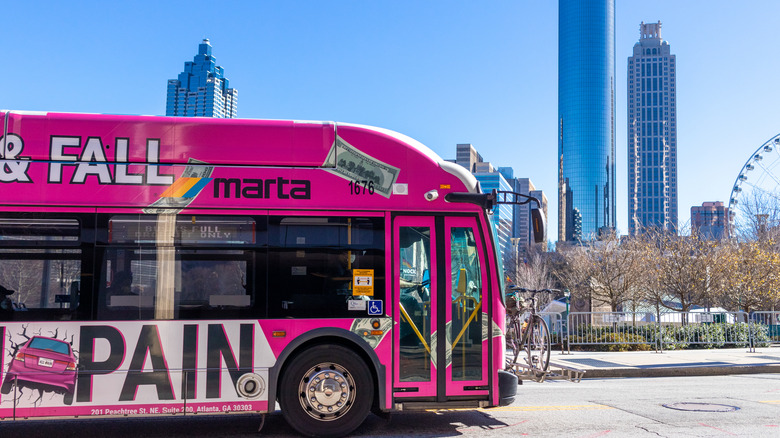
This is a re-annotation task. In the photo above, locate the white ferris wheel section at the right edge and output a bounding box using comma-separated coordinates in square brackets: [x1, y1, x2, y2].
[729, 134, 780, 225]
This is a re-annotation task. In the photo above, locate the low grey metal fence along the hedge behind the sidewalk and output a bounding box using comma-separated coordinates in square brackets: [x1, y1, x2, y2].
[565, 311, 764, 351]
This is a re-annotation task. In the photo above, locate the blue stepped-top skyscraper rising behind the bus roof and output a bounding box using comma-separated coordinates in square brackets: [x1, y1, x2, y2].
[165, 40, 238, 118]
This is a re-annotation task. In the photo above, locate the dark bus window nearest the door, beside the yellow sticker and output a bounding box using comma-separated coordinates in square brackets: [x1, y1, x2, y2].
[268, 217, 385, 318]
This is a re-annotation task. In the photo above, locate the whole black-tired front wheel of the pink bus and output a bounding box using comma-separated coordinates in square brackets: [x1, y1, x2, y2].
[279, 345, 374, 437]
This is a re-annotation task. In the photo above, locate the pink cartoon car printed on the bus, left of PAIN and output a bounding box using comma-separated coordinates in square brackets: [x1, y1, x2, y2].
[0, 336, 76, 405]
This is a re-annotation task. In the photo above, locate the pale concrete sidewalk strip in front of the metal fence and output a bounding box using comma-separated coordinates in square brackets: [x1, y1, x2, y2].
[550, 347, 780, 379]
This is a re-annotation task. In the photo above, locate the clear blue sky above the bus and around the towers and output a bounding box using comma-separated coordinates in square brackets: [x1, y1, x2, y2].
[6, 0, 780, 240]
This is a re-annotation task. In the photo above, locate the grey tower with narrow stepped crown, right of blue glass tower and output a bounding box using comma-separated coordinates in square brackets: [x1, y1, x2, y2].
[627, 21, 677, 236]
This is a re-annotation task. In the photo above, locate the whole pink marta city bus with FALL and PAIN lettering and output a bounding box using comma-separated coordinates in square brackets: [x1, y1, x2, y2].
[0, 111, 544, 436]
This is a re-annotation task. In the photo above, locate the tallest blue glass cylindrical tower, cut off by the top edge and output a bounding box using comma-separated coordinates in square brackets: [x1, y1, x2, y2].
[558, 0, 616, 241]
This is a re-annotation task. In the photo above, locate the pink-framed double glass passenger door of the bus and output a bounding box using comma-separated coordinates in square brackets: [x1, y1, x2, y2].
[393, 216, 489, 402]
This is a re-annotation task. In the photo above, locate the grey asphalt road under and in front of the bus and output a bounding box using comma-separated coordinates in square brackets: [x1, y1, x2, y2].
[0, 374, 780, 438]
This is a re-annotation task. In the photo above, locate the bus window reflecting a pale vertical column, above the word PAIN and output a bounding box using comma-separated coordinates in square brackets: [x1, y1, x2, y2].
[98, 214, 266, 320]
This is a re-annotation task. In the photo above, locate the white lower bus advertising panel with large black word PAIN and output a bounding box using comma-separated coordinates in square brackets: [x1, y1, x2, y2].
[0, 321, 274, 418]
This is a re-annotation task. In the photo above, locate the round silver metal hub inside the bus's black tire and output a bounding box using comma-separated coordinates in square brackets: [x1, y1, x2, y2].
[298, 363, 355, 421]
